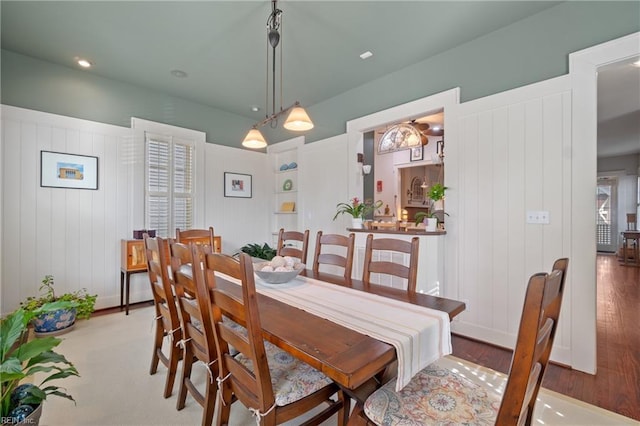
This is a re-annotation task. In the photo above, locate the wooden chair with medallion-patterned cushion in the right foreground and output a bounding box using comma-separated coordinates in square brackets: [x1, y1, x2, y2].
[355, 259, 569, 426]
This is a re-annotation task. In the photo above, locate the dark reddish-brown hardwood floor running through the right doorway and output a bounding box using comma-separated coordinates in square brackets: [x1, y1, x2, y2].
[453, 254, 640, 420]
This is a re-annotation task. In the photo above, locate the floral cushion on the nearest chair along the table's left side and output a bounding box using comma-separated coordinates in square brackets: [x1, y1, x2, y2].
[236, 341, 331, 407]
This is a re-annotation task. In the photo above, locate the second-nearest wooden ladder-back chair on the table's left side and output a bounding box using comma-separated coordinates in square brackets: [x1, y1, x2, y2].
[169, 242, 218, 426]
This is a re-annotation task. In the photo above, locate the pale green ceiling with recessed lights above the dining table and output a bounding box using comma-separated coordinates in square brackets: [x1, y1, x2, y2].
[0, 0, 640, 155]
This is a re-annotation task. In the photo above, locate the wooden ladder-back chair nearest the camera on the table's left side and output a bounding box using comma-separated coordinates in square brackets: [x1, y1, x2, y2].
[201, 253, 350, 425]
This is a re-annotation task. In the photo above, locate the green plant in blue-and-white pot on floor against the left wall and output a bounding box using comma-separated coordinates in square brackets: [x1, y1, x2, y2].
[20, 275, 98, 335]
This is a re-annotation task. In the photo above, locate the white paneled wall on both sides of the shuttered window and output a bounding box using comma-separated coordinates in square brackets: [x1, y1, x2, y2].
[0, 105, 270, 314]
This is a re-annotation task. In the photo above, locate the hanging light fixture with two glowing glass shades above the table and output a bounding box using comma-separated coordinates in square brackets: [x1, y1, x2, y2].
[242, 0, 313, 149]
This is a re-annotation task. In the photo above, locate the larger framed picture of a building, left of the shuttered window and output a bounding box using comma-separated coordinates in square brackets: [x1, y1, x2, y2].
[40, 151, 98, 190]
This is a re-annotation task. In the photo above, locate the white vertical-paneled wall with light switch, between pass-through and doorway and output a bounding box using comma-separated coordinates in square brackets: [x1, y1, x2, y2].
[447, 78, 572, 361]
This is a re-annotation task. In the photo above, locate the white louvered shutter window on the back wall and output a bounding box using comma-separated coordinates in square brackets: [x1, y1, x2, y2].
[145, 133, 194, 237]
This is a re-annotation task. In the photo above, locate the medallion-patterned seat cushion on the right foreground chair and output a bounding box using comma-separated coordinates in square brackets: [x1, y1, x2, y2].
[364, 362, 500, 426]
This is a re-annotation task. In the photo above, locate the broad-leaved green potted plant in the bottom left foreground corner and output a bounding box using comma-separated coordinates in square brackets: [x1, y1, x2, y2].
[0, 301, 79, 425]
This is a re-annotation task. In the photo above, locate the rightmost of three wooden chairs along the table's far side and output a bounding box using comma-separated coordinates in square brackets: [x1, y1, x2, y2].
[362, 234, 420, 293]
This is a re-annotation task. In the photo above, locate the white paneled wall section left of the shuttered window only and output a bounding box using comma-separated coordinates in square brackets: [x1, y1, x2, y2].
[1, 106, 133, 314]
